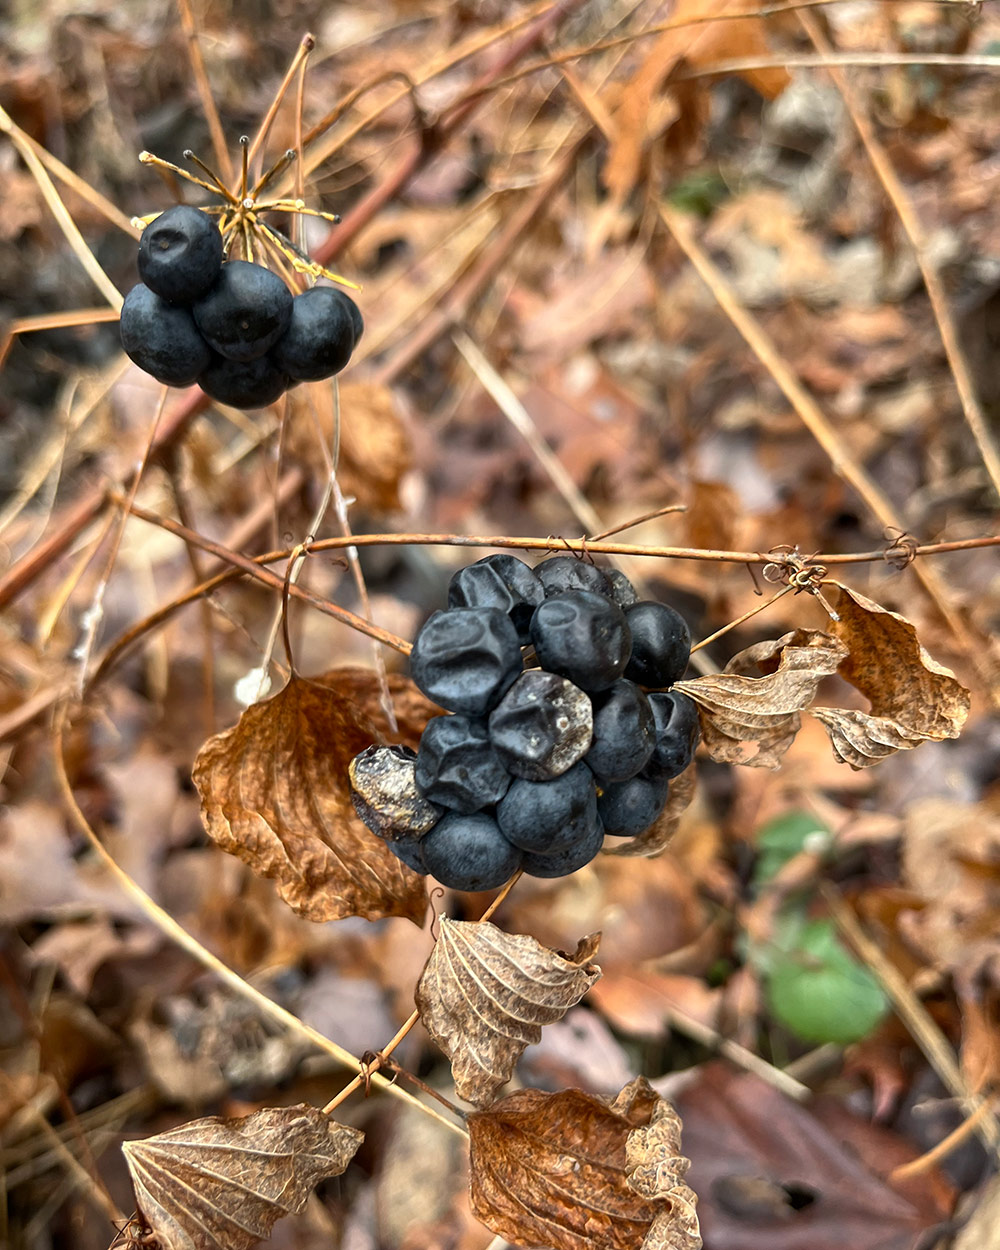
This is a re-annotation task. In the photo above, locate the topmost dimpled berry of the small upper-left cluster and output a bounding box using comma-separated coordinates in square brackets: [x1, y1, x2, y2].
[138, 204, 223, 304]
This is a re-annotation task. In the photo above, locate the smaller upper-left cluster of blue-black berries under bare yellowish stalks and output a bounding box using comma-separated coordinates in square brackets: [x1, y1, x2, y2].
[121, 204, 364, 408]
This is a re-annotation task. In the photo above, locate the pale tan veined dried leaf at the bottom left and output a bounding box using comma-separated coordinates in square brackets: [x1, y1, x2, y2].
[123, 1105, 365, 1250]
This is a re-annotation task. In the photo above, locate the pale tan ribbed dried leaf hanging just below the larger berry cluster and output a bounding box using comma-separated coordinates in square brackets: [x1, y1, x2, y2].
[416, 916, 601, 1106]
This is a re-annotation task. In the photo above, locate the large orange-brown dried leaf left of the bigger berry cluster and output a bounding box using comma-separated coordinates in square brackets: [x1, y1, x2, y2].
[194, 668, 439, 925]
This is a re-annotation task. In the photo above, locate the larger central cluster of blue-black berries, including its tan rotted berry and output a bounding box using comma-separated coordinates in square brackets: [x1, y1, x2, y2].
[350, 555, 699, 890]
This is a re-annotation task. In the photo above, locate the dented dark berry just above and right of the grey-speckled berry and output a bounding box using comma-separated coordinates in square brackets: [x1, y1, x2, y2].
[531, 590, 631, 691]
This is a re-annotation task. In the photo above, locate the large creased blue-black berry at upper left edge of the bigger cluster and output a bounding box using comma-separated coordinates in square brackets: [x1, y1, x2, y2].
[410, 608, 523, 716]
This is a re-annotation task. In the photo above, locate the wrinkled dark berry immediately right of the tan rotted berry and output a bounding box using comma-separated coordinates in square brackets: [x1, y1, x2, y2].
[415, 715, 510, 813]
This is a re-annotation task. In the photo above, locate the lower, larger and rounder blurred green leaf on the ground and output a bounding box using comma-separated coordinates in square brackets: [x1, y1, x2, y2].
[766, 920, 889, 1045]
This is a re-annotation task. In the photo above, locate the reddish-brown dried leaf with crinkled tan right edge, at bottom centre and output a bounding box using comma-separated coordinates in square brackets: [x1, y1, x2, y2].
[469, 1076, 701, 1250]
